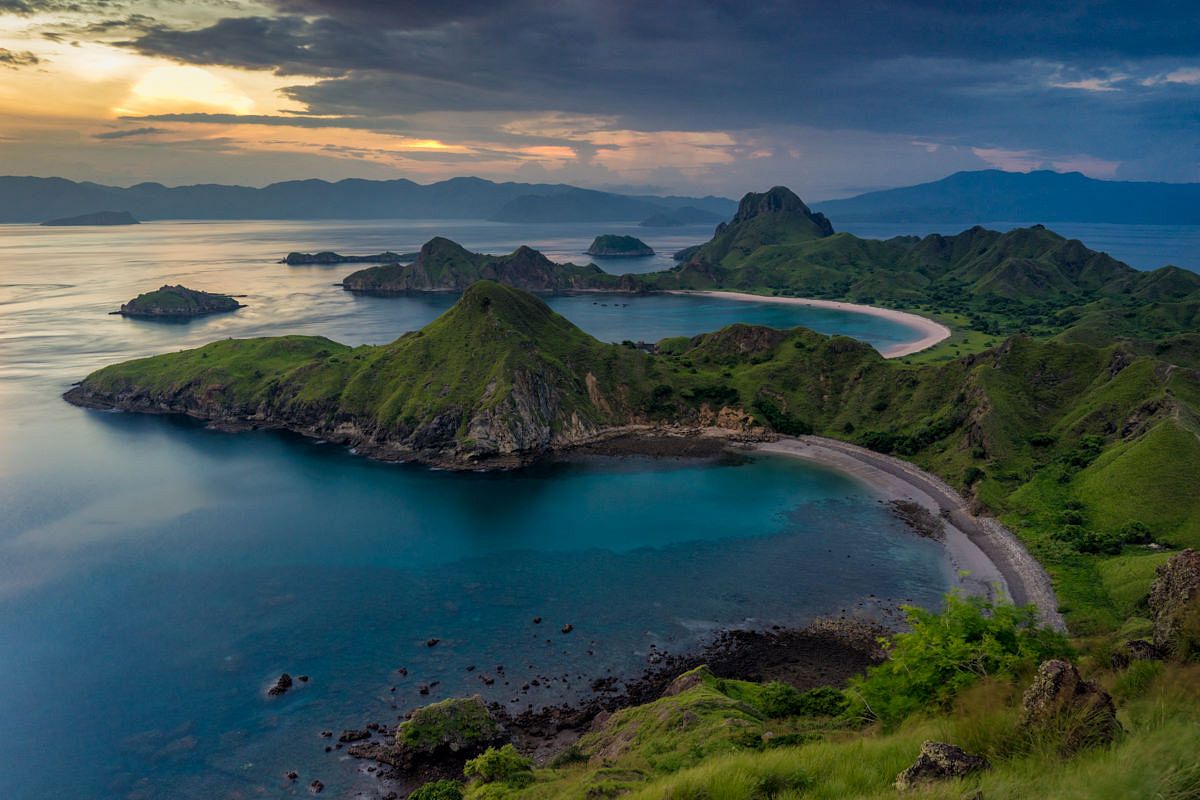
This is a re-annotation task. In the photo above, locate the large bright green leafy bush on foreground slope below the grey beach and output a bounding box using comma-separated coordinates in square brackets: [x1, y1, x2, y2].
[846, 591, 1069, 723]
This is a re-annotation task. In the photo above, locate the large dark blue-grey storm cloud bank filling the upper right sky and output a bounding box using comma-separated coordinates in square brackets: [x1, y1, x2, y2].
[60, 0, 1200, 179]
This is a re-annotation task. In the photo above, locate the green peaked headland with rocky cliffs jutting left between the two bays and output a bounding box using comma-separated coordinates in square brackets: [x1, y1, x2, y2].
[67, 282, 662, 467]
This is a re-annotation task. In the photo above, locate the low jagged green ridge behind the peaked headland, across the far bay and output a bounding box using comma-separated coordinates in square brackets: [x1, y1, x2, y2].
[342, 236, 632, 294]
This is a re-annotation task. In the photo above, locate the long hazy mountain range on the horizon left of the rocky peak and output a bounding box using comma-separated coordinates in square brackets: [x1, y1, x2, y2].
[0, 176, 737, 222]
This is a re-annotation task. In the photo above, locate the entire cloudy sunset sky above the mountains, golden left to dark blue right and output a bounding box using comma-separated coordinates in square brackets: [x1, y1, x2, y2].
[0, 0, 1200, 200]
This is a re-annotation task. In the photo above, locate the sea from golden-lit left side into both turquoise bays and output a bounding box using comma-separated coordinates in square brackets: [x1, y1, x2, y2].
[0, 223, 950, 800]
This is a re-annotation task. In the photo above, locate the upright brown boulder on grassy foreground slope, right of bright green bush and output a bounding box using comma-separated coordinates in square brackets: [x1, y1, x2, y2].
[1021, 658, 1121, 753]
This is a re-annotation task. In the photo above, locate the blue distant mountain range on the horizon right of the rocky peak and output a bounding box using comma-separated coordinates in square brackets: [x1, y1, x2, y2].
[815, 169, 1200, 225]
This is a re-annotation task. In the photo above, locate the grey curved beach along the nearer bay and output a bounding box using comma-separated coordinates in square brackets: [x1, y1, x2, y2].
[752, 437, 1067, 631]
